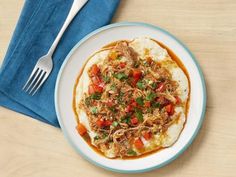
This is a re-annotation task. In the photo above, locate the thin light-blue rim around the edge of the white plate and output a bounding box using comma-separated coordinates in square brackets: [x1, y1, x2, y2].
[54, 22, 207, 173]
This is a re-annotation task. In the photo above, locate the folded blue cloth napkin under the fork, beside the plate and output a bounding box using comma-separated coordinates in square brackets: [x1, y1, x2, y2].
[0, 0, 119, 127]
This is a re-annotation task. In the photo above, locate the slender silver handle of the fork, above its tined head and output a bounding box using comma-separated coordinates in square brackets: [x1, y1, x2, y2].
[47, 0, 88, 56]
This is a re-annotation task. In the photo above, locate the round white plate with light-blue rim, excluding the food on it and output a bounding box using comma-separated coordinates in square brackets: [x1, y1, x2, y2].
[55, 23, 206, 173]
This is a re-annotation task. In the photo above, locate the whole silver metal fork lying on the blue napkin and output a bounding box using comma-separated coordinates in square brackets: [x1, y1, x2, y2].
[22, 0, 88, 96]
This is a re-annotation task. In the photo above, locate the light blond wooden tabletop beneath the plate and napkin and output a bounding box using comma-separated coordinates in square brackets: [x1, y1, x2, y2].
[0, 0, 236, 177]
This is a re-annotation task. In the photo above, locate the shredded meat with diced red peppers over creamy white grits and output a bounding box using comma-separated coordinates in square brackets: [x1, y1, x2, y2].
[73, 37, 190, 158]
